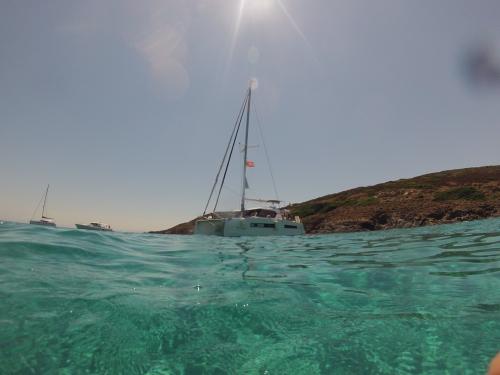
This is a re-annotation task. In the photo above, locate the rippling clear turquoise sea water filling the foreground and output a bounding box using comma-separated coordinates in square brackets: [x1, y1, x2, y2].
[0, 220, 500, 375]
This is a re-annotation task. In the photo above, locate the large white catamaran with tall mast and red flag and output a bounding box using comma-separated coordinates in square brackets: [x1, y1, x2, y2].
[194, 82, 305, 237]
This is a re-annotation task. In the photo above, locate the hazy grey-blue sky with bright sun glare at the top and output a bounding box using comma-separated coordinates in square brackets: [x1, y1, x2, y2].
[0, 0, 500, 231]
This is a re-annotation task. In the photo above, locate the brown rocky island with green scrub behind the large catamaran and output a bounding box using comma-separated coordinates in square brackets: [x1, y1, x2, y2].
[150, 166, 500, 234]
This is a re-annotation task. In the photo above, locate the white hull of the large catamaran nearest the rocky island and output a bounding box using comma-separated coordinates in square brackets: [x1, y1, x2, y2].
[194, 217, 305, 237]
